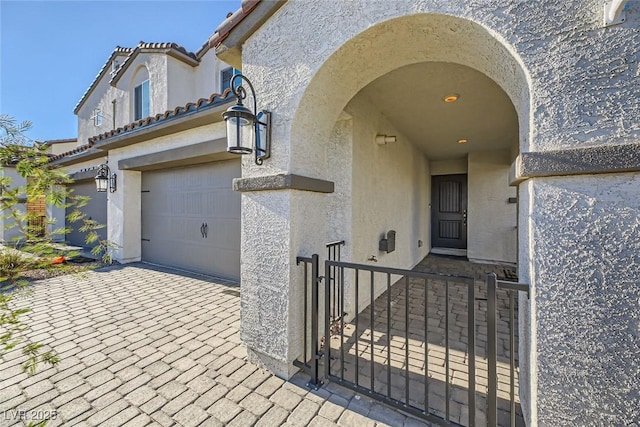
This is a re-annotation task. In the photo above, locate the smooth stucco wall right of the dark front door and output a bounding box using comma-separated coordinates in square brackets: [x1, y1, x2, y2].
[467, 150, 517, 264]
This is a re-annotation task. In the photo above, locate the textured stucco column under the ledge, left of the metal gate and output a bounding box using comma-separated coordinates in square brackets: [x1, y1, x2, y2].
[240, 189, 327, 378]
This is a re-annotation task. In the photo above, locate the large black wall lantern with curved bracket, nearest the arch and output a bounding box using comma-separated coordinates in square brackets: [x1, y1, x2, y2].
[222, 74, 271, 165]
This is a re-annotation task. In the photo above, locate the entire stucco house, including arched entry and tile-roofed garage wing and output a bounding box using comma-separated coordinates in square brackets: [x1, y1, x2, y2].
[47, 0, 640, 426]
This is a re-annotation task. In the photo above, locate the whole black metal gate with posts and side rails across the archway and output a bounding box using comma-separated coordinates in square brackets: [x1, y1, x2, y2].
[296, 246, 528, 426]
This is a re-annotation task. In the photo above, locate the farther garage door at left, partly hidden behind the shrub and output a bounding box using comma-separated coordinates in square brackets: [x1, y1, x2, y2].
[65, 180, 107, 247]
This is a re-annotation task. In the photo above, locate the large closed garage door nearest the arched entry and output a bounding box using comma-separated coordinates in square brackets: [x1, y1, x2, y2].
[142, 160, 240, 280]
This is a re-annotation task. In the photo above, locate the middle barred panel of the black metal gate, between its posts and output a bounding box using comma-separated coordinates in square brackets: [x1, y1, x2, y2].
[324, 261, 476, 425]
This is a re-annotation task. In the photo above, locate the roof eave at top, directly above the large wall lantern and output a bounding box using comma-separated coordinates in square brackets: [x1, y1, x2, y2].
[209, 0, 287, 69]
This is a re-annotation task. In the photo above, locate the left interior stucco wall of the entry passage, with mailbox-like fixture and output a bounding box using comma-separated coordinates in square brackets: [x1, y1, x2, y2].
[344, 95, 431, 316]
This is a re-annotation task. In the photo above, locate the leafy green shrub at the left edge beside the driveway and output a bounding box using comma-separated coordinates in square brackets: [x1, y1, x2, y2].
[0, 115, 110, 374]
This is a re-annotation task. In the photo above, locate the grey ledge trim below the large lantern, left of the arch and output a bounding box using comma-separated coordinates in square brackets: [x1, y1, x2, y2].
[233, 174, 334, 193]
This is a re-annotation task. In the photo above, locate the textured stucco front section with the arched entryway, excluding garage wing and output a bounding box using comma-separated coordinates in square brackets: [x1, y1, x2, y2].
[210, 0, 640, 425]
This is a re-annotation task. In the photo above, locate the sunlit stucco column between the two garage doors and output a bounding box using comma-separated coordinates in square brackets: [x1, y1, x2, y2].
[107, 168, 142, 264]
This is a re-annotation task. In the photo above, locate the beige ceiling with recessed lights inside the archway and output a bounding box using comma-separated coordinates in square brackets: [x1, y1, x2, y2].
[357, 62, 518, 160]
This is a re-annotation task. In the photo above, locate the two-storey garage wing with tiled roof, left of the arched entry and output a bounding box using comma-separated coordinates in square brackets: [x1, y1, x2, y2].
[52, 42, 240, 280]
